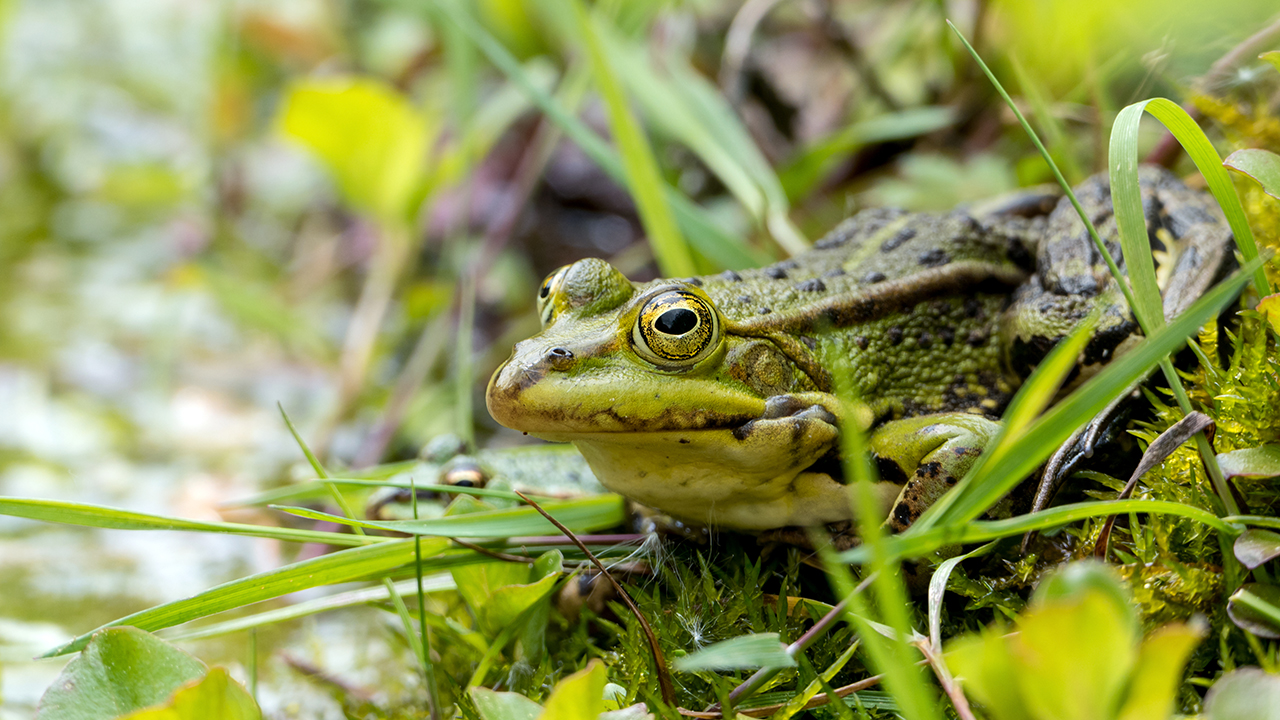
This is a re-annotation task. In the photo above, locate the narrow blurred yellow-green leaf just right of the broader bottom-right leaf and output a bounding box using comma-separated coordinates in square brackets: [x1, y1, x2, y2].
[1116, 623, 1204, 720]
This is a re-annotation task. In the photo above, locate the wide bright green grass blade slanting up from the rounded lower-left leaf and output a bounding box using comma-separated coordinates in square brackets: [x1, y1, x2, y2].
[44, 539, 450, 657]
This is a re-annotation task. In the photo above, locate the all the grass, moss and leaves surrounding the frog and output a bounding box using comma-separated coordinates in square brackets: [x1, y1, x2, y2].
[0, 0, 1280, 720]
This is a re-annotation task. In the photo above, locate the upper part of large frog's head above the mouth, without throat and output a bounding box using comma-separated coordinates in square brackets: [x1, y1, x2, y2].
[486, 259, 764, 439]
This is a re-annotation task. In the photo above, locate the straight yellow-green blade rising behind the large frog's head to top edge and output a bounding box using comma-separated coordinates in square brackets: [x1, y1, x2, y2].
[570, 0, 696, 277]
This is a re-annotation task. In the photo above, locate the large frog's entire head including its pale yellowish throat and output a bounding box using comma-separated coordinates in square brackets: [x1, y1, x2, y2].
[486, 259, 847, 529]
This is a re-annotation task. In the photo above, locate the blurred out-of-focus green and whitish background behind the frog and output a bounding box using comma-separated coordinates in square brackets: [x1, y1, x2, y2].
[0, 0, 1280, 720]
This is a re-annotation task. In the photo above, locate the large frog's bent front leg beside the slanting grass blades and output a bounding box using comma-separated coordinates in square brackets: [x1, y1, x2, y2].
[869, 413, 1000, 533]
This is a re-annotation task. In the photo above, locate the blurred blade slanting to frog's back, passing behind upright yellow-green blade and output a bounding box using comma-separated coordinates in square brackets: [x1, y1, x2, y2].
[435, 3, 771, 268]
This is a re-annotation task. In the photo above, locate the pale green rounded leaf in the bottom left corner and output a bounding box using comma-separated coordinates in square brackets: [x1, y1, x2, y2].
[36, 628, 207, 720]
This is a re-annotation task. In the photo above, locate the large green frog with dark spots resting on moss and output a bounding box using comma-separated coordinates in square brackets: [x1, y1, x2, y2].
[486, 168, 1234, 533]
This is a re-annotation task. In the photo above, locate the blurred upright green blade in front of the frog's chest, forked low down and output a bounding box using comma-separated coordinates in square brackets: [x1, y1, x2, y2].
[813, 352, 940, 720]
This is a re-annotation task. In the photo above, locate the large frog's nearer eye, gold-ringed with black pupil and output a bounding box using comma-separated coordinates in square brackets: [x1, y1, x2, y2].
[631, 290, 719, 366]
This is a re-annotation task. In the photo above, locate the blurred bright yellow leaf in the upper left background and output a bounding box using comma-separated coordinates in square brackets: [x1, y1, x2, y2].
[278, 77, 434, 224]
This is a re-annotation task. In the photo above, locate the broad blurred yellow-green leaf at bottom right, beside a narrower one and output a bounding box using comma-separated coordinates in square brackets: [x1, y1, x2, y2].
[1009, 591, 1138, 720]
